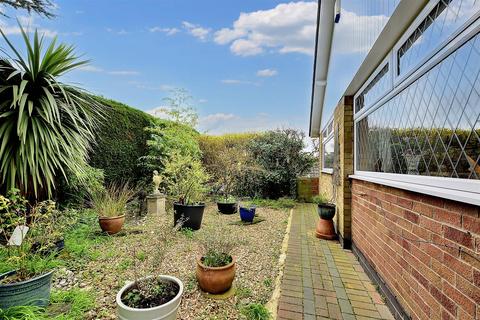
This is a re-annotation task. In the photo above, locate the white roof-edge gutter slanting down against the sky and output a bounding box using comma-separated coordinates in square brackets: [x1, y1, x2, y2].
[310, 0, 340, 137]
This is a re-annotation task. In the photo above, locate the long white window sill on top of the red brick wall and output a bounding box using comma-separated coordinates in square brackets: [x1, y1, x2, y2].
[349, 174, 480, 206]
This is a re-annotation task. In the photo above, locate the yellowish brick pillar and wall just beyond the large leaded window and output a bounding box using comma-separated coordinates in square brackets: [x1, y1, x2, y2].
[319, 97, 353, 247]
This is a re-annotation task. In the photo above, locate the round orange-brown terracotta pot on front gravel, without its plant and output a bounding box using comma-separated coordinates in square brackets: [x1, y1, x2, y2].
[197, 257, 236, 294]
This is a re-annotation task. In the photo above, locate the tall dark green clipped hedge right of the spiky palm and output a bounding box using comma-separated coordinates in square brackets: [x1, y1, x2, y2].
[89, 97, 155, 183]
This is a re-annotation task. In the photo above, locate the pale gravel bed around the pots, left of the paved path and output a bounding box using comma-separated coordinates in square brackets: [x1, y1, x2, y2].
[63, 204, 289, 319]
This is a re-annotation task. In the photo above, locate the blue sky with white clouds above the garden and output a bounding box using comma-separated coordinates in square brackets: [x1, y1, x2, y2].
[0, 0, 390, 133]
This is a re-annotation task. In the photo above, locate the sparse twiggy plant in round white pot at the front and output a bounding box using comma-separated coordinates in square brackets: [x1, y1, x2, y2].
[116, 218, 184, 320]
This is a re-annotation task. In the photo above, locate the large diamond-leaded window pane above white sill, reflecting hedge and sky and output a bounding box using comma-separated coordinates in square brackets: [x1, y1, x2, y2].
[356, 34, 480, 180]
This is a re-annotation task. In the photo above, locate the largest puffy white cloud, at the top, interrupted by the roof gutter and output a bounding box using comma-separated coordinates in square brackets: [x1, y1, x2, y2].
[214, 1, 388, 56]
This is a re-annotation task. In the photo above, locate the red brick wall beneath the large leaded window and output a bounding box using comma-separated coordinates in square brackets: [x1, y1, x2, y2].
[352, 180, 480, 320]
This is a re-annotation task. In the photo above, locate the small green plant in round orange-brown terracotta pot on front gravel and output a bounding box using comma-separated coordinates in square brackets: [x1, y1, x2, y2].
[196, 232, 236, 294]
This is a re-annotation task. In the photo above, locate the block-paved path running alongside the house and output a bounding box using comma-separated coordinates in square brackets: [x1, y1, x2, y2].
[277, 204, 393, 320]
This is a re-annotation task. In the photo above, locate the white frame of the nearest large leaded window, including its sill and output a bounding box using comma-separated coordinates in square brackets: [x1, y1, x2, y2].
[350, 6, 480, 205]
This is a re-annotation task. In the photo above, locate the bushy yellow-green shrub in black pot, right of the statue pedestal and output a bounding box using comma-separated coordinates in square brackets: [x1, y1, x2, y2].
[163, 152, 209, 230]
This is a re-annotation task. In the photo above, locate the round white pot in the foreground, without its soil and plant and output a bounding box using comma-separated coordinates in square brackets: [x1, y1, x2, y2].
[116, 275, 183, 320]
